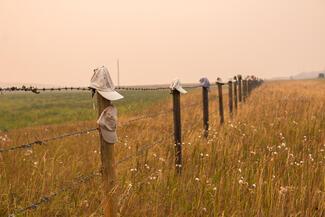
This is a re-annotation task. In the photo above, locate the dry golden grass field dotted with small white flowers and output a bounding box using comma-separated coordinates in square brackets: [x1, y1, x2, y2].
[0, 81, 325, 217]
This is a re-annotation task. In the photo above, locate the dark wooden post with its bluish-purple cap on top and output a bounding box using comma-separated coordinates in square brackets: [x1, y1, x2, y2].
[200, 78, 210, 138]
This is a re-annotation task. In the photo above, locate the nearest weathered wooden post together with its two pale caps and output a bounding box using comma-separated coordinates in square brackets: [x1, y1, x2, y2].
[90, 66, 123, 217]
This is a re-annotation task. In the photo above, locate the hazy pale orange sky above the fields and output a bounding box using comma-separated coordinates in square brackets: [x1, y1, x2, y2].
[0, 0, 325, 85]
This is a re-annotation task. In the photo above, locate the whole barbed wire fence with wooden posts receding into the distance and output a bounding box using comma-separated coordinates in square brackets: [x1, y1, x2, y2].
[0, 75, 263, 217]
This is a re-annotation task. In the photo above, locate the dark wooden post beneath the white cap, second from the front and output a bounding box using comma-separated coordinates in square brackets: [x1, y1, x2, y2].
[172, 89, 182, 174]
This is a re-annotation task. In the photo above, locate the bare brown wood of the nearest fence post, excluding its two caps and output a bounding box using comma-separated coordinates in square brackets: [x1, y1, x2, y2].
[96, 93, 117, 217]
